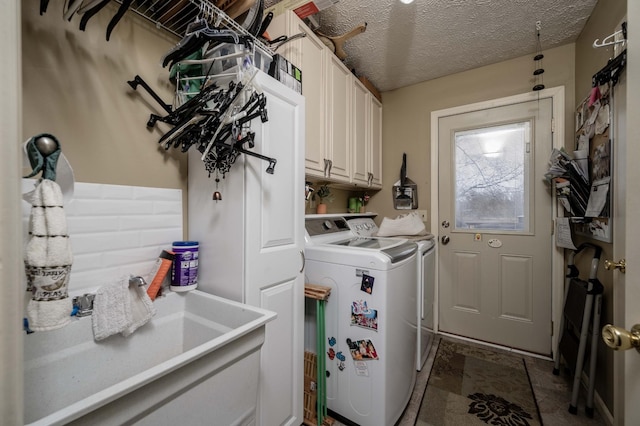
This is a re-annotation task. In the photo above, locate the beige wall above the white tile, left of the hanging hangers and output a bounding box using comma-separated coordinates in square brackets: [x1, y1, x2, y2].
[21, 0, 187, 232]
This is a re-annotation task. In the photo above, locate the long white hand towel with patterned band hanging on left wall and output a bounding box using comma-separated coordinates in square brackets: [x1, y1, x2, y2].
[24, 179, 73, 331]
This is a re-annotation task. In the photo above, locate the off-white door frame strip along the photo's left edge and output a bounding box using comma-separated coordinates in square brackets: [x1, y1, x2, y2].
[0, 1, 25, 425]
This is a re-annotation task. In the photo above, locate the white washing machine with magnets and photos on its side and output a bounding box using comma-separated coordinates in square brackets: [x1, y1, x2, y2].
[305, 215, 417, 426]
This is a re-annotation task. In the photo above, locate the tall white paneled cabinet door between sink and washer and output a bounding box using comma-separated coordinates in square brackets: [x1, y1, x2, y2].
[245, 73, 305, 426]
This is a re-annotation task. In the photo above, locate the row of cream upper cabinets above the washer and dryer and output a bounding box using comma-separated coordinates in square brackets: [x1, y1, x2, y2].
[268, 11, 382, 189]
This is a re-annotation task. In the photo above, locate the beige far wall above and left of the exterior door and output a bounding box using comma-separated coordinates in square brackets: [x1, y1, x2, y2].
[369, 42, 575, 226]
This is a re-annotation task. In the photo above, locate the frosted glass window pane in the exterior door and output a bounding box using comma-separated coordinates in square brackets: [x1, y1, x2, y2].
[454, 121, 531, 233]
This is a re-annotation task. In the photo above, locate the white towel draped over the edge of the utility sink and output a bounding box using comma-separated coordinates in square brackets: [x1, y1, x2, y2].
[91, 277, 156, 341]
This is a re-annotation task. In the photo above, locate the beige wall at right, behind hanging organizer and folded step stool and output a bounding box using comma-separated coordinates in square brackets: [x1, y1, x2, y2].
[567, 0, 626, 414]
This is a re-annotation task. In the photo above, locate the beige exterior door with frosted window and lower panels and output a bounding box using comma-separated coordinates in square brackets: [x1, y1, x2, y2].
[438, 98, 552, 355]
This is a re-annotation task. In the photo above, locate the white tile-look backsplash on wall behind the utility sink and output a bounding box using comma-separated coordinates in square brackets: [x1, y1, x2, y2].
[22, 179, 182, 297]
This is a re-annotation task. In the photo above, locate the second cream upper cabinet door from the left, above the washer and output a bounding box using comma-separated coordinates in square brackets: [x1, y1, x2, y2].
[328, 55, 353, 182]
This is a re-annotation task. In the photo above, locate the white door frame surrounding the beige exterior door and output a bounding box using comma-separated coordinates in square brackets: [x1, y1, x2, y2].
[431, 86, 565, 356]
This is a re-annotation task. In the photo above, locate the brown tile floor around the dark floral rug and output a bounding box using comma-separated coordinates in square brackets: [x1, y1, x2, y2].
[334, 336, 607, 426]
